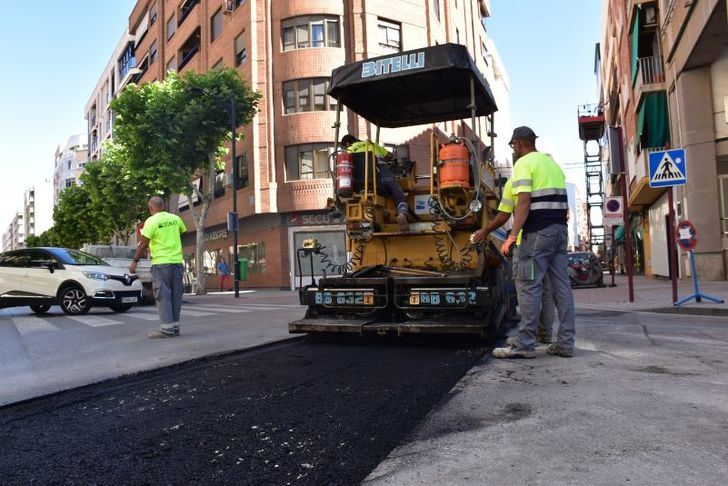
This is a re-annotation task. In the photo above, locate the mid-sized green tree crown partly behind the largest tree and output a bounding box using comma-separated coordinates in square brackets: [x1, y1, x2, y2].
[81, 142, 153, 245]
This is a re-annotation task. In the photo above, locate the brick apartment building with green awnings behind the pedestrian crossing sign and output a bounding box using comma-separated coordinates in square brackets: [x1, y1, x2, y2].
[599, 0, 728, 280]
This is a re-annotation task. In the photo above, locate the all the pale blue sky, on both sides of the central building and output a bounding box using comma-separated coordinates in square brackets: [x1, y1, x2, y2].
[0, 0, 603, 232]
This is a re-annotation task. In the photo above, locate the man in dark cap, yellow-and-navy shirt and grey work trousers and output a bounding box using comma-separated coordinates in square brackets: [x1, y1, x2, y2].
[493, 127, 576, 358]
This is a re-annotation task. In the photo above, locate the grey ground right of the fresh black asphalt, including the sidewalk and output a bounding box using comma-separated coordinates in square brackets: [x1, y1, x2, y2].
[364, 298, 728, 486]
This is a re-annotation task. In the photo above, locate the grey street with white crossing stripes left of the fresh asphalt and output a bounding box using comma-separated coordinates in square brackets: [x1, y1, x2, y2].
[0, 291, 303, 405]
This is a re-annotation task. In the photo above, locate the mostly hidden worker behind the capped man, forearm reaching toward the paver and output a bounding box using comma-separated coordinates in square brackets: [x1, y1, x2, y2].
[472, 179, 554, 344]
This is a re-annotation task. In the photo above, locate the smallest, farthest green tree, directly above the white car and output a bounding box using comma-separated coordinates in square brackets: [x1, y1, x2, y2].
[49, 185, 104, 249]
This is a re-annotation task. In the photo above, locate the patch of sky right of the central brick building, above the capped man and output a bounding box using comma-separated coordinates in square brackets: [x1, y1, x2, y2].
[485, 0, 604, 186]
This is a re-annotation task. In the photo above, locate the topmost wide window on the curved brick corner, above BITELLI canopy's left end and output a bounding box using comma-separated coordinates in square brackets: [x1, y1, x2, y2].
[281, 15, 341, 51]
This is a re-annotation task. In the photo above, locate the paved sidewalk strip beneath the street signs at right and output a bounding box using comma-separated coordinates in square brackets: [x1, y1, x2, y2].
[574, 274, 728, 315]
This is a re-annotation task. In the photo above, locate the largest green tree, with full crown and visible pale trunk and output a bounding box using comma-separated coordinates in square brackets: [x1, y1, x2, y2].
[111, 69, 260, 294]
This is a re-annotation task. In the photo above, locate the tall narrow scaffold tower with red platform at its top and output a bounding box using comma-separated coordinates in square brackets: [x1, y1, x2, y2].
[577, 104, 606, 255]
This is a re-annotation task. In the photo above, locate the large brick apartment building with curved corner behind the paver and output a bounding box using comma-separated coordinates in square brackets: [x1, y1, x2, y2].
[87, 0, 510, 288]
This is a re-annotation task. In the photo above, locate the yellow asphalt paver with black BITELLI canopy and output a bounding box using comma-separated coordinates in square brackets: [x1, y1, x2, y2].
[289, 44, 515, 337]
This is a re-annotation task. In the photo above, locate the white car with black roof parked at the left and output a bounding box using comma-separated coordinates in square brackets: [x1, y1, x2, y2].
[0, 248, 142, 315]
